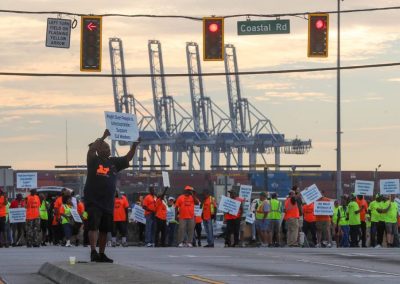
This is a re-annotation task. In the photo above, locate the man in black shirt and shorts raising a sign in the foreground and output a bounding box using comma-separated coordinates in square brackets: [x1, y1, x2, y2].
[84, 129, 140, 263]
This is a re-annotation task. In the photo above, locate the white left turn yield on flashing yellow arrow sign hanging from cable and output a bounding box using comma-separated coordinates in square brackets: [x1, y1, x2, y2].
[46, 18, 71, 48]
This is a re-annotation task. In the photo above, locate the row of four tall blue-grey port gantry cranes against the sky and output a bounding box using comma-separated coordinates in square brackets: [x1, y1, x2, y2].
[109, 38, 311, 170]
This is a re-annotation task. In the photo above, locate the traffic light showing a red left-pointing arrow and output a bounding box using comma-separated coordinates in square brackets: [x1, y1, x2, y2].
[81, 16, 102, 72]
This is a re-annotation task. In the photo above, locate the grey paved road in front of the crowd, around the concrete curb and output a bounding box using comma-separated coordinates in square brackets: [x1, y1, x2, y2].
[0, 244, 400, 284]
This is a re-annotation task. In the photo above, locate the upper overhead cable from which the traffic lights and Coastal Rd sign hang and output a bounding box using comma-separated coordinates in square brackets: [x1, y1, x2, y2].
[0, 6, 400, 21]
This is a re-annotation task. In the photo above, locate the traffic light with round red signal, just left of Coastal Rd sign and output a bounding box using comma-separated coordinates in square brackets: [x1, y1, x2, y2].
[203, 17, 224, 61]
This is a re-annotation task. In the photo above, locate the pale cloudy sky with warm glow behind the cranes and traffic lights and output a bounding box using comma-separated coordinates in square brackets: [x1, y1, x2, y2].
[0, 0, 400, 171]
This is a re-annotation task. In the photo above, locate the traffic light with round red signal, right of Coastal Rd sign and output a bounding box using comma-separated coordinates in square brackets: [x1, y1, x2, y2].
[308, 14, 329, 57]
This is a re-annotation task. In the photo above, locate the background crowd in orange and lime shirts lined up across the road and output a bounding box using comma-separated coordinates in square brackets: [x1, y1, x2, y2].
[0, 186, 400, 251]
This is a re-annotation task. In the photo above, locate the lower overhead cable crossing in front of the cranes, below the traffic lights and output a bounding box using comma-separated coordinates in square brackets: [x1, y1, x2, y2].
[0, 62, 400, 78]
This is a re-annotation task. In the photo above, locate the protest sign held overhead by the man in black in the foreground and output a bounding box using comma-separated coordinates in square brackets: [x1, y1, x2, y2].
[104, 111, 139, 142]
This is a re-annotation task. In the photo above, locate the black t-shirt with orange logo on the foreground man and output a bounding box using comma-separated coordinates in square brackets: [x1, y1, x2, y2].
[84, 157, 129, 214]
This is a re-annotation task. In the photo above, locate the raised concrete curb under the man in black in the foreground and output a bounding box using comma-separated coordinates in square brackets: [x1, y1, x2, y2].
[39, 262, 187, 284]
